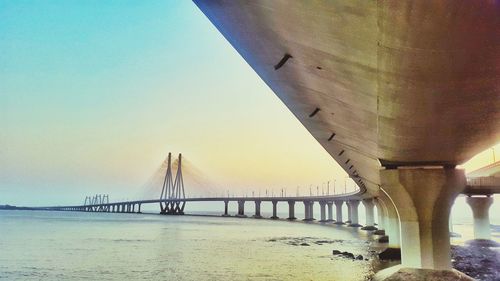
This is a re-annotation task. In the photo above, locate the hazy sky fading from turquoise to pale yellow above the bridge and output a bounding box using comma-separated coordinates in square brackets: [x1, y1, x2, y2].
[0, 0, 498, 205]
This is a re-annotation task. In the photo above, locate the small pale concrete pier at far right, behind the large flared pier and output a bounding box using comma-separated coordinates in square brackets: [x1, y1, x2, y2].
[465, 196, 493, 239]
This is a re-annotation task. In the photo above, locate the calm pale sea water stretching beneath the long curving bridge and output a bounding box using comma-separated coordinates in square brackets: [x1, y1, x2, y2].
[0, 211, 372, 280]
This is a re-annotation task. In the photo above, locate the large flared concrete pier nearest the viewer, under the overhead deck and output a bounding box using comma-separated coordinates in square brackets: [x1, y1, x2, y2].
[380, 168, 466, 270]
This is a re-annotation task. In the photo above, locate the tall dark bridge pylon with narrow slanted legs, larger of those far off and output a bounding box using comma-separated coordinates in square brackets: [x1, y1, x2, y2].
[160, 153, 186, 215]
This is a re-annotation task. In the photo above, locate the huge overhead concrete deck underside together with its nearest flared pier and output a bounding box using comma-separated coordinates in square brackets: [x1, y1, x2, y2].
[194, 0, 500, 276]
